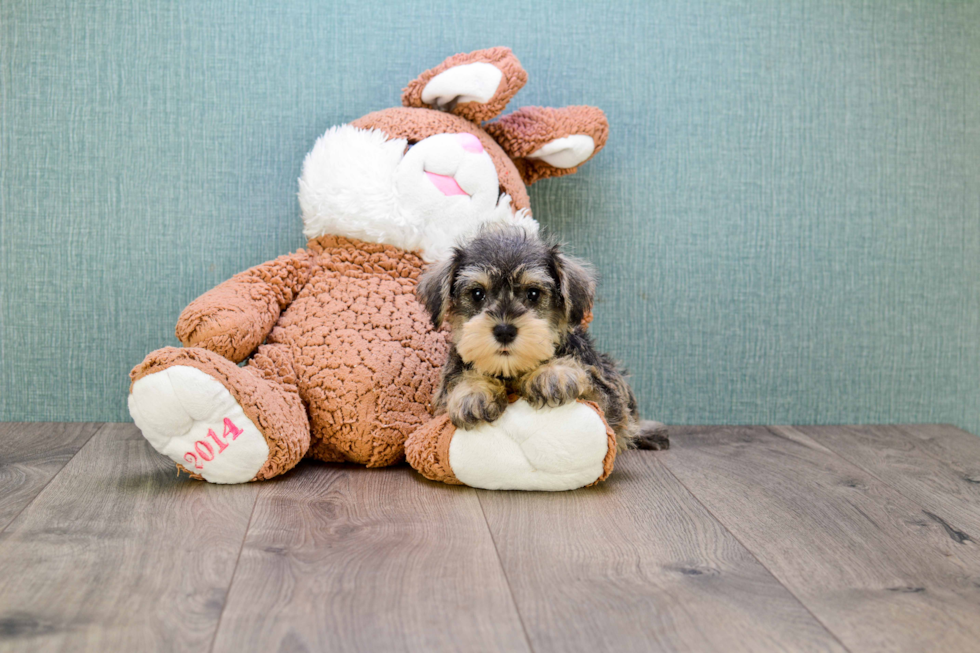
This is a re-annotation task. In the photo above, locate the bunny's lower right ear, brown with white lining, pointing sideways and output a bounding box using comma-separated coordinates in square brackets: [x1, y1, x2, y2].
[485, 107, 609, 185]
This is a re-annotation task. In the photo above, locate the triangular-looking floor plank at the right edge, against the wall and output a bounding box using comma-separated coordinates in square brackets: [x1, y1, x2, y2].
[792, 426, 980, 541]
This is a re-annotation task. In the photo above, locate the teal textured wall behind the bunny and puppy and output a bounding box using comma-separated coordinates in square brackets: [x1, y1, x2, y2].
[0, 0, 980, 433]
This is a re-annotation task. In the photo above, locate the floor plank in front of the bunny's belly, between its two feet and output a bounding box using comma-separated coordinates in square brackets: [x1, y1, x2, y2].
[214, 463, 528, 651]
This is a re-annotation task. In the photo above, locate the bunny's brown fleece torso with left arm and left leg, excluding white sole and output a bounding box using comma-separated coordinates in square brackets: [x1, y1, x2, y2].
[132, 236, 448, 468]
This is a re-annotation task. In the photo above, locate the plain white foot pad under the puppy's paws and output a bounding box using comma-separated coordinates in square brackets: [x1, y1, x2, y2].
[449, 399, 609, 491]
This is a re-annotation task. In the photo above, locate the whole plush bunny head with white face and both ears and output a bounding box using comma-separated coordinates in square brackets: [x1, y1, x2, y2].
[299, 48, 608, 261]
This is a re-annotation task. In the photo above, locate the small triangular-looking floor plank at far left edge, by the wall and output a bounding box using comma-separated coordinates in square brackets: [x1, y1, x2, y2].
[0, 422, 102, 531]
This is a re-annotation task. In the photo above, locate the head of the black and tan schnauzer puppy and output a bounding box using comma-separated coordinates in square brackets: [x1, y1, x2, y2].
[417, 227, 595, 377]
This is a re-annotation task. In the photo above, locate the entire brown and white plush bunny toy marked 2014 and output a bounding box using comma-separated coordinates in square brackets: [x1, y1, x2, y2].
[129, 48, 615, 490]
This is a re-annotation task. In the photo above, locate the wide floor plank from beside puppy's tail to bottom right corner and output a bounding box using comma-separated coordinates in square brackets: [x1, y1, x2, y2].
[661, 427, 980, 651]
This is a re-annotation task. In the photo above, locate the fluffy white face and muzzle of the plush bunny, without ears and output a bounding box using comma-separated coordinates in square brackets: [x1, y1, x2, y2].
[299, 125, 537, 260]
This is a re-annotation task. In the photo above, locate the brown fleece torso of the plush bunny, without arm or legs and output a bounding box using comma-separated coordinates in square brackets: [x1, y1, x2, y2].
[269, 236, 448, 467]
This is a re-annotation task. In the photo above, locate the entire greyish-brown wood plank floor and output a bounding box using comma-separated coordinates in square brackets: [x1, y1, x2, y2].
[0, 424, 980, 653]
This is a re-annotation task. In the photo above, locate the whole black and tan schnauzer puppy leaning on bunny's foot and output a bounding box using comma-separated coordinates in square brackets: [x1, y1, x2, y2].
[417, 227, 668, 449]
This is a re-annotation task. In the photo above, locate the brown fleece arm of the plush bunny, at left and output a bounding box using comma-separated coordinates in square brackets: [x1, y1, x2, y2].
[176, 249, 313, 363]
